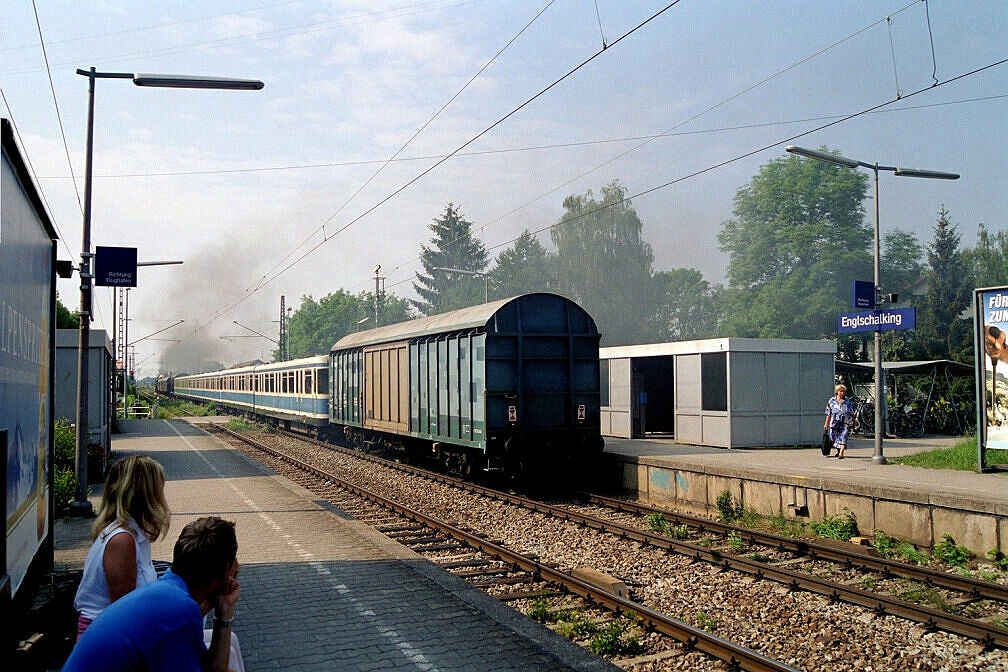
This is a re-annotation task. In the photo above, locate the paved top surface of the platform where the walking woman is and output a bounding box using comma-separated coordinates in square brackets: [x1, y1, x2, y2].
[606, 436, 1008, 511]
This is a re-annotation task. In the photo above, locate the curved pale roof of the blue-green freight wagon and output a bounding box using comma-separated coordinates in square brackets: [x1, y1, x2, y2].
[331, 292, 595, 352]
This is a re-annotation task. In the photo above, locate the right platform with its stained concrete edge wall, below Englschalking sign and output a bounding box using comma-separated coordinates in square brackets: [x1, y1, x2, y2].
[604, 436, 1008, 557]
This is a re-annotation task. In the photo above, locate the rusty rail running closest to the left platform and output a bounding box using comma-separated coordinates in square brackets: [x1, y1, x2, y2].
[220, 427, 796, 672]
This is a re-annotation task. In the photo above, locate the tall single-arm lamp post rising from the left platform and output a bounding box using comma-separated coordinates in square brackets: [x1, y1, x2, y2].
[70, 66, 263, 516]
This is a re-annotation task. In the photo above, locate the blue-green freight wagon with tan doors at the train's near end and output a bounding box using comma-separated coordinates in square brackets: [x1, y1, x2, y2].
[330, 293, 603, 475]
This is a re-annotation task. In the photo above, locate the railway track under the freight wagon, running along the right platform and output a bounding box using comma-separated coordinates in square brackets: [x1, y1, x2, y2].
[235, 425, 1008, 649]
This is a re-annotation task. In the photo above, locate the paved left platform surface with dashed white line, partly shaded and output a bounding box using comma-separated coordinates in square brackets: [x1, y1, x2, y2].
[55, 420, 618, 672]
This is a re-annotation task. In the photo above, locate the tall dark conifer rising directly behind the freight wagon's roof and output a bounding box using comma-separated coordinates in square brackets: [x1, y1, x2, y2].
[412, 204, 488, 315]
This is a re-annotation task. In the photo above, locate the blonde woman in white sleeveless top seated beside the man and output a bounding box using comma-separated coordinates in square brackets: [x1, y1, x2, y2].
[74, 455, 171, 639]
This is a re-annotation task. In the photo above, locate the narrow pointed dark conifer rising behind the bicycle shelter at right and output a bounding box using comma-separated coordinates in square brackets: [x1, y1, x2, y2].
[916, 206, 972, 359]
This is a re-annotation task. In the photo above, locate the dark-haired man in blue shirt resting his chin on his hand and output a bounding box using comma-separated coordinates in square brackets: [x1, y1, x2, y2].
[62, 517, 241, 672]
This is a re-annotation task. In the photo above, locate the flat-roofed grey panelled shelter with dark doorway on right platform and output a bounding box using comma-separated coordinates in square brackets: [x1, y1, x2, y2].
[599, 339, 837, 447]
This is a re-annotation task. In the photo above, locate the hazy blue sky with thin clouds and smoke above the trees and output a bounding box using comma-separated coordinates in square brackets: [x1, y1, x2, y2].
[0, 0, 1008, 377]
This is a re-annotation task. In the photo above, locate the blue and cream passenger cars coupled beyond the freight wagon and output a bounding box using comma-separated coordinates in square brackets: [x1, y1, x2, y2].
[173, 355, 330, 434]
